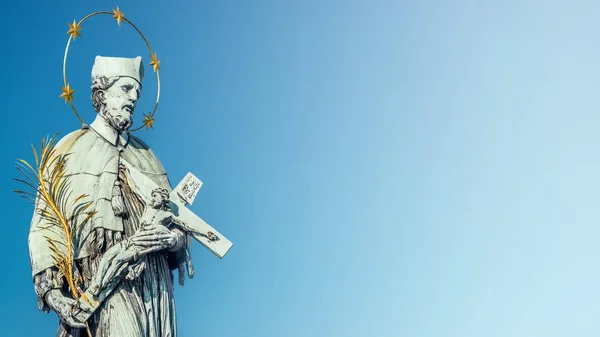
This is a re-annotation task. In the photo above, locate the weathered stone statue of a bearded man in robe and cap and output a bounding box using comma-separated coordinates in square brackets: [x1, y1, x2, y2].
[29, 56, 190, 337]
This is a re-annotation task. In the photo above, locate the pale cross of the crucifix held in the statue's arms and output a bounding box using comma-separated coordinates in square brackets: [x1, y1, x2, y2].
[74, 161, 233, 322]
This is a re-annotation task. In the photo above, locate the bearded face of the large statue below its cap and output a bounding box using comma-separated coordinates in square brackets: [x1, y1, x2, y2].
[101, 77, 142, 131]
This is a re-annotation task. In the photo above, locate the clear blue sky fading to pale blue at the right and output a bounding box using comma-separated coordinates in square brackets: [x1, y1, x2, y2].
[0, 0, 600, 337]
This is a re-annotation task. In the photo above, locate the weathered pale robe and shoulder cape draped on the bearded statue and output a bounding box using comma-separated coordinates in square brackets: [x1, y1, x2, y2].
[29, 129, 186, 337]
